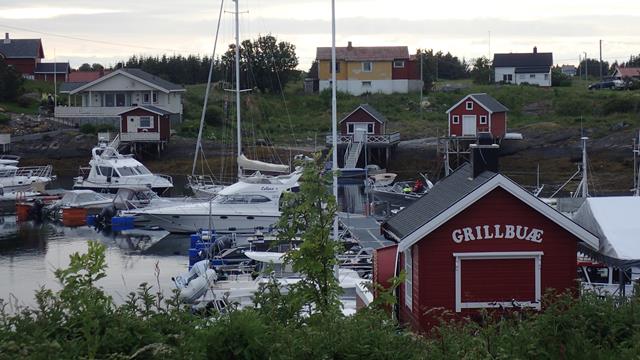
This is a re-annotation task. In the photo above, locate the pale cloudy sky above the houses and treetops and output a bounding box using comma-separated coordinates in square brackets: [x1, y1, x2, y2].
[0, 0, 640, 70]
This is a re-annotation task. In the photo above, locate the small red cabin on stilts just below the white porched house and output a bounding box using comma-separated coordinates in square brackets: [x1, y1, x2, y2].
[120, 106, 171, 142]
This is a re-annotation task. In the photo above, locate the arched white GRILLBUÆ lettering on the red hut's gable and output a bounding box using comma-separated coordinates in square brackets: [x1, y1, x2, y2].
[451, 224, 544, 244]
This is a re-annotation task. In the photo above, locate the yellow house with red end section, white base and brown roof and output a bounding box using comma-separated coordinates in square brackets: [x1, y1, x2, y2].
[316, 41, 422, 95]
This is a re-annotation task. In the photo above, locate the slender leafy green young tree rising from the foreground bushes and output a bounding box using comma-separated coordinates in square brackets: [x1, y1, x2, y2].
[277, 156, 341, 314]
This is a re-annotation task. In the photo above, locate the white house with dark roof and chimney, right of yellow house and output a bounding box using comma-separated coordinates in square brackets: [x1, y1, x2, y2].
[493, 47, 553, 86]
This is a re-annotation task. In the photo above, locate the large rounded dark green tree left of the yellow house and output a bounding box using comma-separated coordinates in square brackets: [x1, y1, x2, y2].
[222, 35, 298, 93]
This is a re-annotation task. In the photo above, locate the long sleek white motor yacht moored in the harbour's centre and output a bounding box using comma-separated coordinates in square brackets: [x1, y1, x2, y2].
[122, 170, 302, 235]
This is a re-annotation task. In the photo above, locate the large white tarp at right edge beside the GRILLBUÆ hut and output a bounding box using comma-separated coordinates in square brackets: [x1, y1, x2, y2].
[573, 196, 640, 264]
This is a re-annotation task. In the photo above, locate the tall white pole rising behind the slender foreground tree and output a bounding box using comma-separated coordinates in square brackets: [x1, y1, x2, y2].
[331, 0, 338, 240]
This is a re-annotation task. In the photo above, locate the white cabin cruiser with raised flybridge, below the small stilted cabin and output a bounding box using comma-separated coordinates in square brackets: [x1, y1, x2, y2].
[73, 140, 173, 194]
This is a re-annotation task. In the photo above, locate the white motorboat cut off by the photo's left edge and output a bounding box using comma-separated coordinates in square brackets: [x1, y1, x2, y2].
[0, 156, 55, 194]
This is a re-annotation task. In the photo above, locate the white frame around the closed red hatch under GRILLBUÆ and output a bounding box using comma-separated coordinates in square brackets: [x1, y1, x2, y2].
[453, 251, 544, 312]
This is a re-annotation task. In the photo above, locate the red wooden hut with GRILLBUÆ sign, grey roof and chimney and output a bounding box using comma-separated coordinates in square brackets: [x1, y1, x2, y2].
[374, 147, 598, 331]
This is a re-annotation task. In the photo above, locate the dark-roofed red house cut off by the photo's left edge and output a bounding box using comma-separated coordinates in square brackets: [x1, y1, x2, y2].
[0, 33, 44, 79]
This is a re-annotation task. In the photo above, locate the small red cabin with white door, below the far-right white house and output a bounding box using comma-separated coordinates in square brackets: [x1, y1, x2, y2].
[447, 93, 509, 139]
